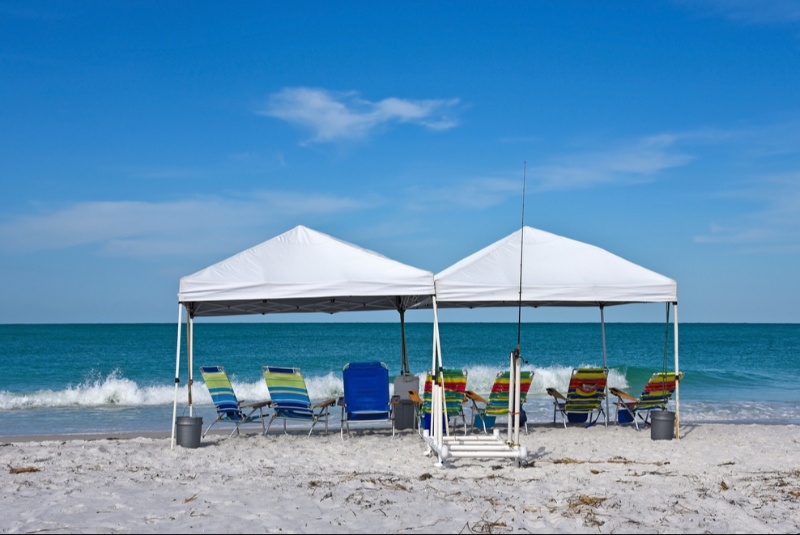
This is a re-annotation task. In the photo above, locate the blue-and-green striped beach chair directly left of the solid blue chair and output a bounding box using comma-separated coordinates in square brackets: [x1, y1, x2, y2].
[261, 366, 336, 436]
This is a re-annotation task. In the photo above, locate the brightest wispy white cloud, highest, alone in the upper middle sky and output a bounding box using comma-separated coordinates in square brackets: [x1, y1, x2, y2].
[257, 87, 459, 143]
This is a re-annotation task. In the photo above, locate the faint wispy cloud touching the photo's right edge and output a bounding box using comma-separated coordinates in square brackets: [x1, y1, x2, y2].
[695, 172, 800, 253]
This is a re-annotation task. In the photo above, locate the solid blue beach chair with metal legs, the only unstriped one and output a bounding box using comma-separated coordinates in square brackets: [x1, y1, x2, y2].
[339, 362, 400, 439]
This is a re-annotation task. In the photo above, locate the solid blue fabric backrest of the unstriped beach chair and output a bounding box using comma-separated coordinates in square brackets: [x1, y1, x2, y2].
[342, 361, 389, 412]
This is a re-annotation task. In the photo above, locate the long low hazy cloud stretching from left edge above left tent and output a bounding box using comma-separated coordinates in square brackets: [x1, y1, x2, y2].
[0, 191, 379, 256]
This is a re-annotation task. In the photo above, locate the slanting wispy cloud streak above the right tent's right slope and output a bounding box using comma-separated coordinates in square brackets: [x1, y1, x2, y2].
[529, 134, 693, 190]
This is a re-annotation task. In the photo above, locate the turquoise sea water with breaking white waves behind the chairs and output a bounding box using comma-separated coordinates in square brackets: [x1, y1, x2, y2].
[0, 322, 800, 435]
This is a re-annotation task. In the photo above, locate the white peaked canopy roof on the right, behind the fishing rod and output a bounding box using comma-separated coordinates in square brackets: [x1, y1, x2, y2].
[435, 227, 678, 307]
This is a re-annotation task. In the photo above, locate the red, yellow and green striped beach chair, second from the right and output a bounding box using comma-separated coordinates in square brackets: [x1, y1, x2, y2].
[547, 368, 608, 427]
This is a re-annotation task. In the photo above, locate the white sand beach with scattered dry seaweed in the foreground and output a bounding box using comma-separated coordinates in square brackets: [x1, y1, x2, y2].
[0, 424, 800, 533]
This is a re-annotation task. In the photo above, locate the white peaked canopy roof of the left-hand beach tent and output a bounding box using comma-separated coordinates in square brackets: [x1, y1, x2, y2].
[178, 225, 434, 316]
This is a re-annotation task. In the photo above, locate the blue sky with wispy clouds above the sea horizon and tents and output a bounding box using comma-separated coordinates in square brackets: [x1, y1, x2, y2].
[0, 0, 800, 323]
